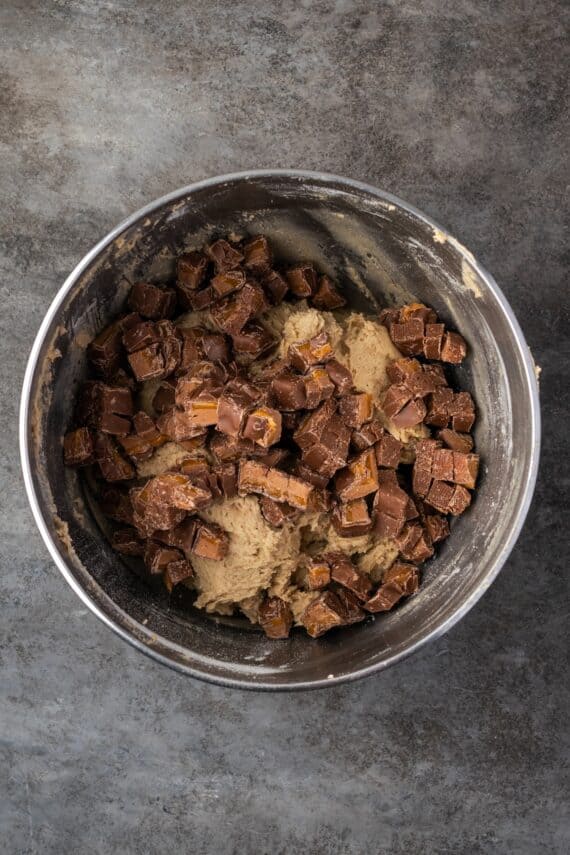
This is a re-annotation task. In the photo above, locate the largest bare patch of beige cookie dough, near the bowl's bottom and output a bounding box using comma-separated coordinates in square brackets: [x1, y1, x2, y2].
[192, 496, 300, 612]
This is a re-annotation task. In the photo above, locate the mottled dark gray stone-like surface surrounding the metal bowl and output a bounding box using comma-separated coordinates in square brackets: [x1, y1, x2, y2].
[0, 0, 570, 855]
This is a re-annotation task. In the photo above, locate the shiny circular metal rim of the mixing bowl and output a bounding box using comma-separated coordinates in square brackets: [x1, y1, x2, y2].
[19, 169, 541, 691]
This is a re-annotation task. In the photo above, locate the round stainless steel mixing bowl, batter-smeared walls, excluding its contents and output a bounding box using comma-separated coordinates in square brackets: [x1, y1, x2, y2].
[20, 170, 540, 689]
